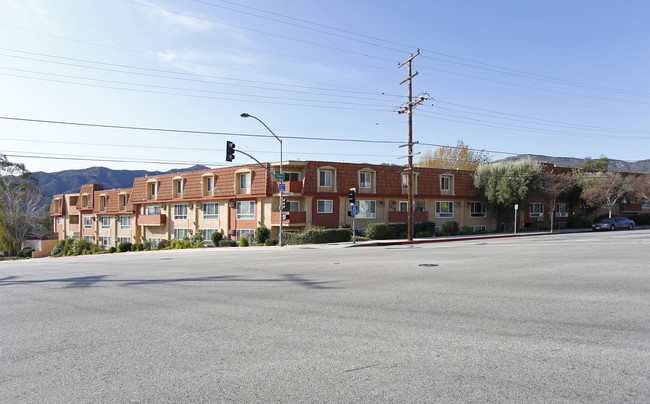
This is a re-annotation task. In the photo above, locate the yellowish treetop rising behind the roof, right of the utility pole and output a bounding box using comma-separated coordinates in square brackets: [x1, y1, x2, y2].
[415, 140, 492, 171]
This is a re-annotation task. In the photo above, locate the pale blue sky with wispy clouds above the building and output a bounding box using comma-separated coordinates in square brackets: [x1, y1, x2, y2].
[0, 0, 650, 172]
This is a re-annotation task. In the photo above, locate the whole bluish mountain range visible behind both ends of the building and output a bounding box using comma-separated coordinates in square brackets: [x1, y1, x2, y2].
[32, 154, 650, 197]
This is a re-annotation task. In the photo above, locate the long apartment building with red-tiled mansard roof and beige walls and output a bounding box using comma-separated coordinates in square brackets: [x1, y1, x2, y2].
[50, 161, 650, 246]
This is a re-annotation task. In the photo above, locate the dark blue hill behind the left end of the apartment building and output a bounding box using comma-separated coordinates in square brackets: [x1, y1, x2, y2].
[32, 165, 210, 197]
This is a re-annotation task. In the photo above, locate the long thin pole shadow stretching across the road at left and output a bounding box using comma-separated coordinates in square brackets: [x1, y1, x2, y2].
[0, 274, 340, 289]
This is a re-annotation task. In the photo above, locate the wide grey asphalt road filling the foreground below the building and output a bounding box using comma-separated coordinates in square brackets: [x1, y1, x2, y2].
[0, 230, 650, 403]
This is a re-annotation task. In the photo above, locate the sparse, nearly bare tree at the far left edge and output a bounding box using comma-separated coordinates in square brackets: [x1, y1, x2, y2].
[0, 155, 45, 254]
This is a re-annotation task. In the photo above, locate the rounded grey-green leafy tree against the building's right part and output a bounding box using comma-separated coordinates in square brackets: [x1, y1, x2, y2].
[474, 159, 546, 227]
